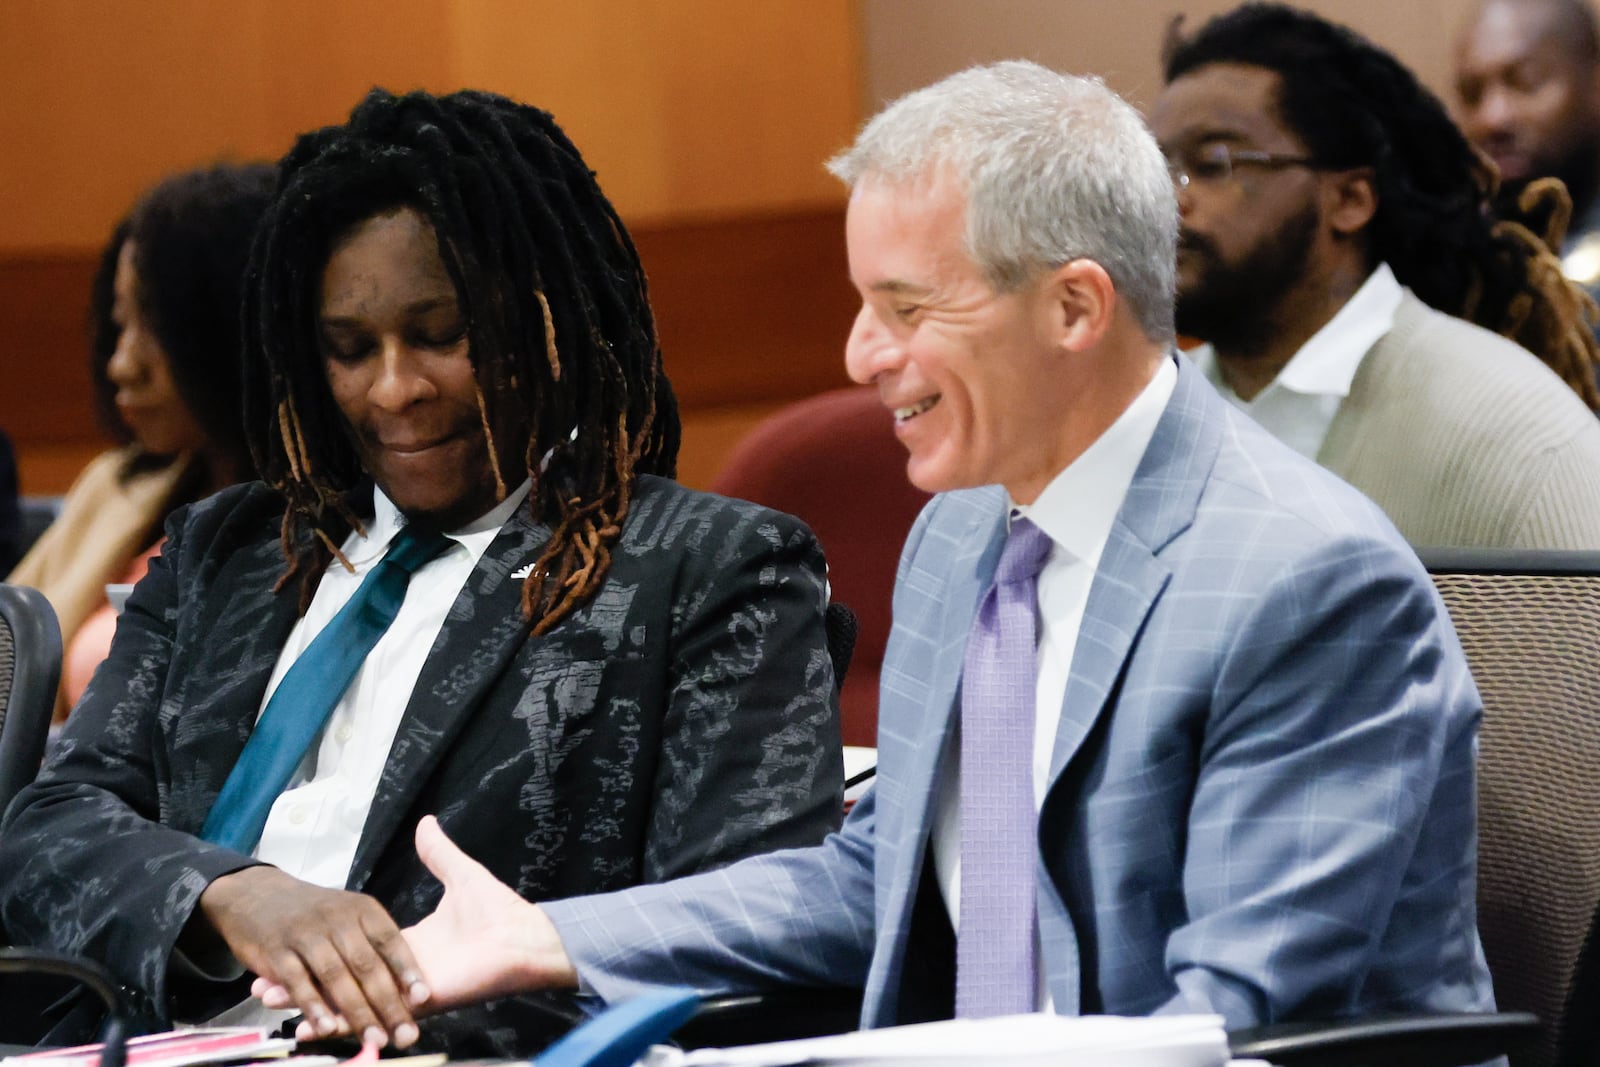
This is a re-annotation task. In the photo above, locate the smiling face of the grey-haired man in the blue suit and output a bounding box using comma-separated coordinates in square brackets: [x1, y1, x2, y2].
[845, 179, 1074, 504]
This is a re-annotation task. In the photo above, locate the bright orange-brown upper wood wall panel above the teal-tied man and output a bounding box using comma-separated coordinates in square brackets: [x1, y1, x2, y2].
[0, 0, 861, 254]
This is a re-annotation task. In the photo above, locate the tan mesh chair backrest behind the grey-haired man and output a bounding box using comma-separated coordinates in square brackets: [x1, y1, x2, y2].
[1422, 550, 1600, 1067]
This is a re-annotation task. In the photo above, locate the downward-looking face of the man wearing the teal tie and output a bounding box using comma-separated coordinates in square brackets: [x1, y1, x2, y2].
[318, 208, 502, 530]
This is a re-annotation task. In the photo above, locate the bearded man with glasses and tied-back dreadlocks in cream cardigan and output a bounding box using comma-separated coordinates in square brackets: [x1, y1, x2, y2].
[1150, 3, 1600, 549]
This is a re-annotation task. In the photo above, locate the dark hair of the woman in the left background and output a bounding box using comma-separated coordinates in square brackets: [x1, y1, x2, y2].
[90, 163, 274, 483]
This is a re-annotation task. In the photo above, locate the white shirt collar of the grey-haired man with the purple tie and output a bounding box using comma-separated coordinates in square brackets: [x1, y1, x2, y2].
[1011, 351, 1178, 566]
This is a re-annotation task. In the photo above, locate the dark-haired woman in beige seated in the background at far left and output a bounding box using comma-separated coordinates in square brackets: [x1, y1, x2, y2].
[6, 163, 274, 723]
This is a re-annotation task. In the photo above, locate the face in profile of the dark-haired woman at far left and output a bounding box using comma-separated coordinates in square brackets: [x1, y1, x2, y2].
[106, 242, 208, 456]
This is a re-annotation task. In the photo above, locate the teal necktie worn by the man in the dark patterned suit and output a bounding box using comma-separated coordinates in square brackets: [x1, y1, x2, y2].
[200, 526, 450, 853]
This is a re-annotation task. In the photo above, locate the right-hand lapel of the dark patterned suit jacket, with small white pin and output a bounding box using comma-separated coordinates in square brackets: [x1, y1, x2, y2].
[347, 507, 550, 889]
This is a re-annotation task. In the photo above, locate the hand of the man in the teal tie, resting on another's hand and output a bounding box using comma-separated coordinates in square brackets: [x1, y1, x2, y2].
[186, 867, 429, 1048]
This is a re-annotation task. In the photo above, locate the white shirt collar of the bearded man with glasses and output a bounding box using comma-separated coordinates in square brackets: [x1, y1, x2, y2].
[1184, 262, 1405, 459]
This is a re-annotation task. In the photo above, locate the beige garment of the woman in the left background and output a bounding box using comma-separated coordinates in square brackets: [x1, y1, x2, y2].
[6, 448, 190, 721]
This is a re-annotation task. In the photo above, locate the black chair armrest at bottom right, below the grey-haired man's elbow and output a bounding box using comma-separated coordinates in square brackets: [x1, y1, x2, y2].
[1227, 1011, 1539, 1067]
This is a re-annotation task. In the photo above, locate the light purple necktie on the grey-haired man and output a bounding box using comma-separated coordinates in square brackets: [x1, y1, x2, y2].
[955, 518, 1050, 1019]
